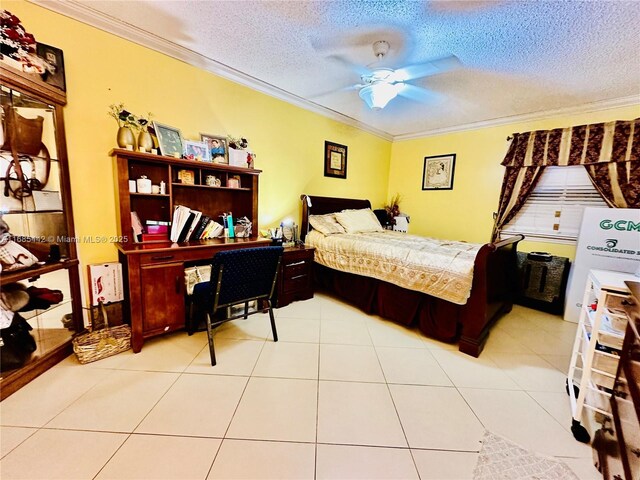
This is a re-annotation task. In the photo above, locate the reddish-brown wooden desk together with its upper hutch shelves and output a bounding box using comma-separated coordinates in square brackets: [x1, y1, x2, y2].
[111, 149, 269, 352]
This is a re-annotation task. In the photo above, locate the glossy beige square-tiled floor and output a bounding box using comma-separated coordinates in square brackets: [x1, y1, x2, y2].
[0, 295, 599, 480]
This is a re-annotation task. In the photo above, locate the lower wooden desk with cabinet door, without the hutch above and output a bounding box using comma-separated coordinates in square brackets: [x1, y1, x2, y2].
[116, 237, 270, 353]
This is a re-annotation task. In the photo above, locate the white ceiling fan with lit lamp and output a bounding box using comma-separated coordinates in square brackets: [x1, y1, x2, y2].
[331, 40, 462, 110]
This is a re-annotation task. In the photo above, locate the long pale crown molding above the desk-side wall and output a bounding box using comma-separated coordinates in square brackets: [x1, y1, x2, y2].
[29, 0, 393, 141]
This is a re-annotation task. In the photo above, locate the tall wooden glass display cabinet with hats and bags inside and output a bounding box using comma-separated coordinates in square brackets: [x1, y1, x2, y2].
[0, 66, 84, 399]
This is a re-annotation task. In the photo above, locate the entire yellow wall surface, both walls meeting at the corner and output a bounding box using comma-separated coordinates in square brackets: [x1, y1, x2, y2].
[2, 0, 640, 300]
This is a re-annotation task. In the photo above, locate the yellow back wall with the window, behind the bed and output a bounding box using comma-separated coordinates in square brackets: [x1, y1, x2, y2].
[389, 105, 640, 258]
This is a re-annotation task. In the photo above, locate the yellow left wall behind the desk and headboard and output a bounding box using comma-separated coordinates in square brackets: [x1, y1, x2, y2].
[7, 0, 391, 280]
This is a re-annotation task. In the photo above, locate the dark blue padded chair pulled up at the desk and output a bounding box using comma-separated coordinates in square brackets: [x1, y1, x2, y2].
[192, 247, 283, 366]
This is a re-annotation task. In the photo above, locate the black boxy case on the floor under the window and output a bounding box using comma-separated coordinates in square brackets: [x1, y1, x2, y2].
[516, 252, 571, 315]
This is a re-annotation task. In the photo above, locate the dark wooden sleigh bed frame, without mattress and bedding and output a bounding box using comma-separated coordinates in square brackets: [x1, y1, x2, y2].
[301, 195, 524, 357]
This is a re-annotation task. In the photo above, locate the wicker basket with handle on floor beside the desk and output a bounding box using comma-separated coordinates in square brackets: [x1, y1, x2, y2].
[73, 303, 131, 364]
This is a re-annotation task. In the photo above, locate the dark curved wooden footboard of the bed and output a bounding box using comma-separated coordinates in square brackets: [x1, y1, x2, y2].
[459, 235, 524, 357]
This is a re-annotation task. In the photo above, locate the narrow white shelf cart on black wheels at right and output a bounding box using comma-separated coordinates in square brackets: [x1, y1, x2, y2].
[567, 270, 638, 443]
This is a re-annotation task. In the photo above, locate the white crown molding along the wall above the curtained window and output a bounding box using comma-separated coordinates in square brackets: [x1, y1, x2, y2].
[393, 95, 640, 142]
